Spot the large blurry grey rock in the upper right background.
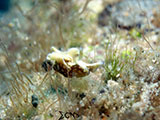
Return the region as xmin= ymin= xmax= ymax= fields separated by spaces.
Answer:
xmin=98 ymin=0 xmax=160 ymax=29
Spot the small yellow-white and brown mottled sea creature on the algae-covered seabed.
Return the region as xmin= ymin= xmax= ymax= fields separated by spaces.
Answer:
xmin=46 ymin=47 xmax=103 ymax=76
